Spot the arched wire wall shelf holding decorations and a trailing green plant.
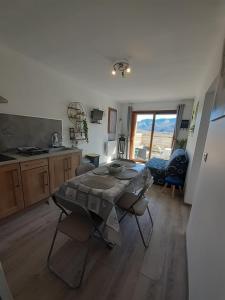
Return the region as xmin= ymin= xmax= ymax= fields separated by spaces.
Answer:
xmin=67 ymin=102 xmax=88 ymax=145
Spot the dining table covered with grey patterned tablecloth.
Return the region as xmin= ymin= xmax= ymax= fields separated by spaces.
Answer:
xmin=55 ymin=160 xmax=153 ymax=245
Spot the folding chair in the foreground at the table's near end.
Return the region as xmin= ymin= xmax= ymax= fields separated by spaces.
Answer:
xmin=47 ymin=193 xmax=104 ymax=288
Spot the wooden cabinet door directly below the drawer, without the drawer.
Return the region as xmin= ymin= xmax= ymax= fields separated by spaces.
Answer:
xmin=22 ymin=166 xmax=49 ymax=207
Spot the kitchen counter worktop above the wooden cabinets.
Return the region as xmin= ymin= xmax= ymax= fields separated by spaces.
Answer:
xmin=0 ymin=148 xmax=82 ymax=166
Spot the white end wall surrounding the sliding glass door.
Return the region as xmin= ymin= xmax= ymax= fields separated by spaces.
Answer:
xmin=119 ymin=99 xmax=194 ymax=139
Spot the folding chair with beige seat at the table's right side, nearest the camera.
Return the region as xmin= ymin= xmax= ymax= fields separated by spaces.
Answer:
xmin=117 ymin=180 xmax=154 ymax=248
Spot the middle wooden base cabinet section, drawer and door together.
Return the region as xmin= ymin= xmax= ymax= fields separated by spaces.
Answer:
xmin=21 ymin=159 xmax=49 ymax=207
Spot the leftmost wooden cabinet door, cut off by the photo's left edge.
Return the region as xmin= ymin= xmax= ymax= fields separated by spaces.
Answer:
xmin=0 ymin=164 xmax=24 ymax=218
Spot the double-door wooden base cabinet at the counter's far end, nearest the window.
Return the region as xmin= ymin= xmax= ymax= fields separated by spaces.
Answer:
xmin=49 ymin=153 xmax=80 ymax=193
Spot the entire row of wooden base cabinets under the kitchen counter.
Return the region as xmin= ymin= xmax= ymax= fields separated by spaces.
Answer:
xmin=0 ymin=152 xmax=81 ymax=218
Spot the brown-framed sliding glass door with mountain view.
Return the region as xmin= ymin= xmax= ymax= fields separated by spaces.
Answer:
xmin=130 ymin=111 xmax=176 ymax=161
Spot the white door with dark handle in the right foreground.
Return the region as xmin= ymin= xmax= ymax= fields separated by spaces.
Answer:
xmin=187 ymin=118 xmax=225 ymax=300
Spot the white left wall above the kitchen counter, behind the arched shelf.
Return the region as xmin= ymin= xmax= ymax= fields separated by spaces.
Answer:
xmin=0 ymin=46 xmax=116 ymax=161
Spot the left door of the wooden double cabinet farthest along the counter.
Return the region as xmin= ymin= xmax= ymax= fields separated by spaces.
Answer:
xmin=49 ymin=155 xmax=70 ymax=193
